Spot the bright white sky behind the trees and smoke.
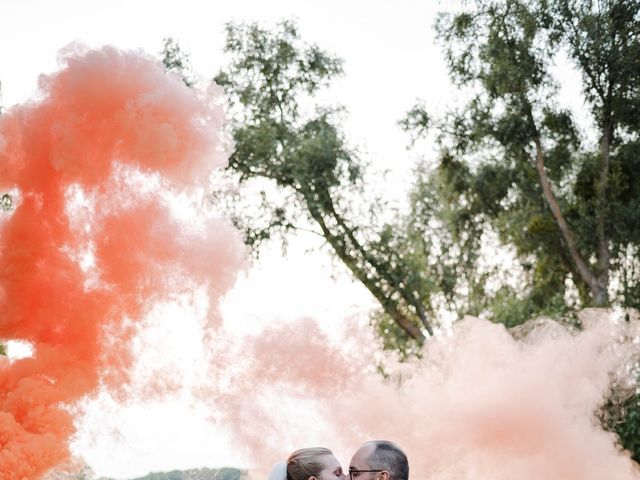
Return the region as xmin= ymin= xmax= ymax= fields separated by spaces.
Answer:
xmin=0 ymin=0 xmax=584 ymax=477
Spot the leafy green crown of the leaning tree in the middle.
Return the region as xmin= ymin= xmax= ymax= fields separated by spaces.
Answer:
xmin=215 ymin=21 xmax=350 ymax=244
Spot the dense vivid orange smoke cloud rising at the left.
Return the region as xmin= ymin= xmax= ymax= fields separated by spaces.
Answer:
xmin=0 ymin=46 xmax=243 ymax=480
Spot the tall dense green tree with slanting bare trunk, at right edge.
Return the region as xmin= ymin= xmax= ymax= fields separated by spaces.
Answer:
xmin=403 ymin=0 xmax=640 ymax=323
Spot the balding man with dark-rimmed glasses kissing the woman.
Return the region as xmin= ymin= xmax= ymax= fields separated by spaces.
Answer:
xmin=349 ymin=440 xmax=409 ymax=480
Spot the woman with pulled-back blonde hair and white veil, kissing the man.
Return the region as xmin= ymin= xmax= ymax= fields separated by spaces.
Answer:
xmin=268 ymin=447 xmax=348 ymax=480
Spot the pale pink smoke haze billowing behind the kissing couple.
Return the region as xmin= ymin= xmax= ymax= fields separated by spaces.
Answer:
xmin=224 ymin=312 xmax=640 ymax=480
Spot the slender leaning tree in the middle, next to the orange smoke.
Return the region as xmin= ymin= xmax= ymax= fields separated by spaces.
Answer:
xmin=215 ymin=21 xmax=440 ymax=345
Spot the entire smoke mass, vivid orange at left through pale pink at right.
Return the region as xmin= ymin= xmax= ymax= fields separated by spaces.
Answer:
xmin=0 ymin=45 xmax=640 ymax=480
